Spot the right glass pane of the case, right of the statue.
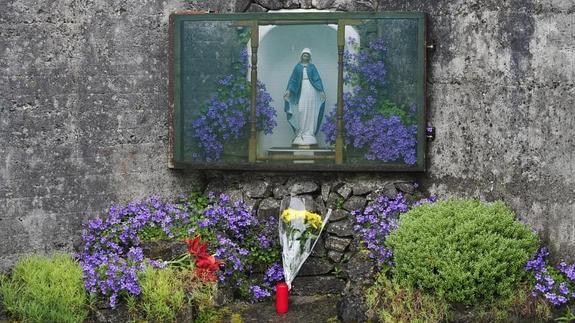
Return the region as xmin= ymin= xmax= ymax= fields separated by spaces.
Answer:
xmin=336 ymin=18 xmax=423 ymax=166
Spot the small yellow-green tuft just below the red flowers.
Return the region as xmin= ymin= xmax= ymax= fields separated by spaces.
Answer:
xmin=139 ymin=267 xmax=186 ymax=322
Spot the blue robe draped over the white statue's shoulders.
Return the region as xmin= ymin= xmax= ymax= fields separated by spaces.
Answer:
xmin=284 ymin=63 xmax=325 ymax=135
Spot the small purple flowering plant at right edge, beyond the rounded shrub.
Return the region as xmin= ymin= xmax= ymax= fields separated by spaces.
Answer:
xmin=525 ymin=247 xmax=575 ymax=306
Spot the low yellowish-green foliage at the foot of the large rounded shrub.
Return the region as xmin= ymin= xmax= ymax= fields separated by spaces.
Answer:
xmin=366 ymin=271 xmax=449 ymax=323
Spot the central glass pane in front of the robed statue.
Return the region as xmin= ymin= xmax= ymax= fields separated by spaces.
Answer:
xmin=258 ymin=24 xmax=337 ymax=163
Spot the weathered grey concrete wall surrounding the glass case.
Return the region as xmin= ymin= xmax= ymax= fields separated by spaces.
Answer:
xmin=0 ymin=0 xmax=575 ymax=268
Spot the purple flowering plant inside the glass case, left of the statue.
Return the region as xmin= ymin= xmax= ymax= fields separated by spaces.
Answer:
xmin=190 ymin=49 xmax=276 ymax=161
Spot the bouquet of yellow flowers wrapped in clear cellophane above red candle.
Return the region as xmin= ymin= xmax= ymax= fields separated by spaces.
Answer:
xmin=279 ymin=196 xmax=331 ymax=289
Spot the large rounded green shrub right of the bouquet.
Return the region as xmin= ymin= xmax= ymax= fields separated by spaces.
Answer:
xmin=386 ymin=200 xmax=538 ymax=305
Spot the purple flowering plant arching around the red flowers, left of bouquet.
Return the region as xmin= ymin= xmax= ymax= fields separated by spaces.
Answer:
xmin=77 ymin=194 xmax=283 ymax=307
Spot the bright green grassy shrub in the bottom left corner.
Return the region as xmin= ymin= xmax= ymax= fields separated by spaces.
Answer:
xmin=0 ymin=254 xmax=88 ymax=322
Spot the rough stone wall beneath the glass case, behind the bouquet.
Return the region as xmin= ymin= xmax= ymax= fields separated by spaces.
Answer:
xmin=200 ymin=174 xmax=423 ymax=322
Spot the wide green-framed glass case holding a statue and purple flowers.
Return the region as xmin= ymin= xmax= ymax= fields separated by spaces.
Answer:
xmin=169 ymin=12 xmax=426 ymax=171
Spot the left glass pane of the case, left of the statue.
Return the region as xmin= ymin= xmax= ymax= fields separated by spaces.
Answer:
xmin=180 ymin=21 xmax=251 ymax=163
